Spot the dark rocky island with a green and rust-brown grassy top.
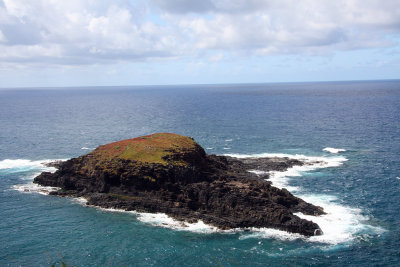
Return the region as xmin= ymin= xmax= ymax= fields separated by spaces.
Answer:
xmin=34 ymin=133 xmax=324 ymax=236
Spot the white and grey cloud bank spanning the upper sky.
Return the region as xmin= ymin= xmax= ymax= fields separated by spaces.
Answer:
xmin=0 ymin=0 xmax=400 ymax=68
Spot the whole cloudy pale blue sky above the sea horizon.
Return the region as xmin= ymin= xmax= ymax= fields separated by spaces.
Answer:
xmin=0 ymin=0 xmax=400 ymax=88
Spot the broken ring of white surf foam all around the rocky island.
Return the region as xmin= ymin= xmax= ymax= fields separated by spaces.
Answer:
xmin=9 ymin=153 xmax=385 ymax=245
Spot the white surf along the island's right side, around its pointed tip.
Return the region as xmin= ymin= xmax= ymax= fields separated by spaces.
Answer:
xmin=228 ymin=153 xmax=385 ymax=245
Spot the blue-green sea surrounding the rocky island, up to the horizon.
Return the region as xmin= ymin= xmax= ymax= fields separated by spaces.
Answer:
xmin=0 ymin=80 xmax=400 ymax=266
